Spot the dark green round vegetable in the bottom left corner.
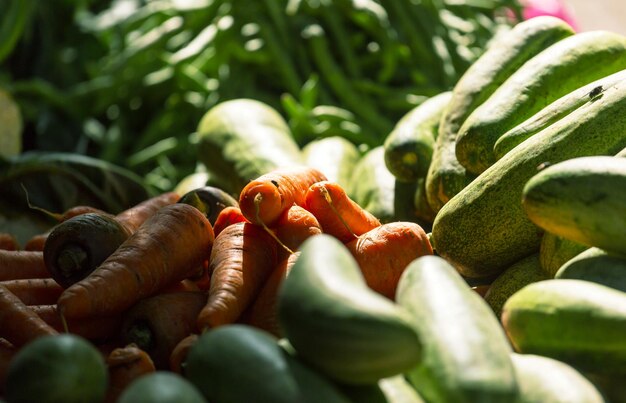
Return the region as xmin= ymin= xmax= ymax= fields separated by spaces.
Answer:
xmin=4 ymin=334 xmax=108 ymax=403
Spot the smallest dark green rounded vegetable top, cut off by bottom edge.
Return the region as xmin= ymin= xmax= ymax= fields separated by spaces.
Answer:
xmin=117 ymin=371 xmax=206 ymax=403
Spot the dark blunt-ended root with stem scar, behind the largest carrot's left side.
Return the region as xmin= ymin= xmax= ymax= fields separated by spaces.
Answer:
xmin=43 ymin=213 xmax=130 ymax=288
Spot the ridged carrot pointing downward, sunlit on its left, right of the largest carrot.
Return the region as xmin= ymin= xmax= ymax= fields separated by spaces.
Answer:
xmin=197 ymin=222 xmax=278 ymax=331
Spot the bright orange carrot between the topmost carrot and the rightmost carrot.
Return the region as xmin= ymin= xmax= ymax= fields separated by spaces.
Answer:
xmin=305 ymin=181 xmax=381 ymax=243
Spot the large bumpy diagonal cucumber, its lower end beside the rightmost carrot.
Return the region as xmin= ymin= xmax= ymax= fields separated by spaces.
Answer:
xmin=431 ymin=81 xmax=626 ymax=278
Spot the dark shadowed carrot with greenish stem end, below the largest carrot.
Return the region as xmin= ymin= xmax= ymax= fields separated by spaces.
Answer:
xmin=120 ymin=292 xmax=207 ymax=369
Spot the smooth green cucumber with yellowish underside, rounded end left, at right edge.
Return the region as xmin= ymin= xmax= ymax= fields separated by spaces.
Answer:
xmin=522 ymin=156 xmax=626 ymax=256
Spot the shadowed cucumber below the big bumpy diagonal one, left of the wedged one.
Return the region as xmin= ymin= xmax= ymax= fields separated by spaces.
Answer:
xmin=484 ymin=253 xmax=548 ymax=318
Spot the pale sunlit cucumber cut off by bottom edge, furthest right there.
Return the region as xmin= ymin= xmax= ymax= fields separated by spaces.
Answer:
xmin=511 ymin=353 xmax=604 ymax=403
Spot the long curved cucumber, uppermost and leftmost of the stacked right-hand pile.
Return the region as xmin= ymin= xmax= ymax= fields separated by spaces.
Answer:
xmin=426 ymin=16 xmax=574 ymax=212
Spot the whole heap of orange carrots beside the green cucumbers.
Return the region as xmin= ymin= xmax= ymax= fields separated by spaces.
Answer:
xmin=0 ymin=167 xmax=433 ymax=395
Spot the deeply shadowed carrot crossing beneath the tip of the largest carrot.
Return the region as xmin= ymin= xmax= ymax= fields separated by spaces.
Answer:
xmin=29 ymin=304 xmax=122 ymax=342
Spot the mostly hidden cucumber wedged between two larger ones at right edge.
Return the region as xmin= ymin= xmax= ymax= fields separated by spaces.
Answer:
xmin=554 ymin=248 xmax=626 ymax=292
